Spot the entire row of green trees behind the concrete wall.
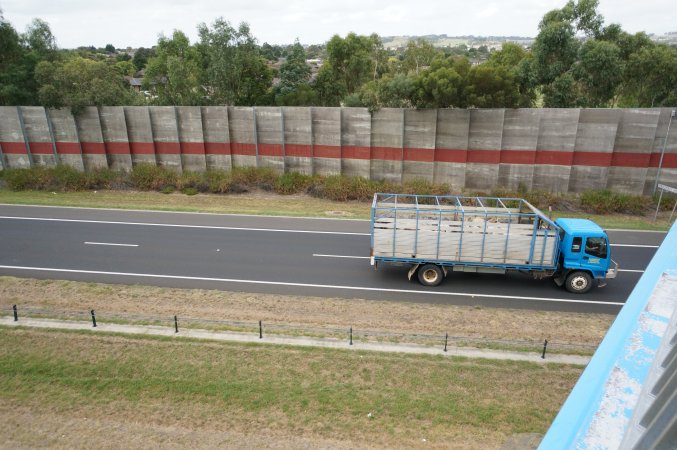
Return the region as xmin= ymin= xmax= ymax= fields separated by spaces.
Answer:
xmin=0 ymin=0 xmax=677 ymax=113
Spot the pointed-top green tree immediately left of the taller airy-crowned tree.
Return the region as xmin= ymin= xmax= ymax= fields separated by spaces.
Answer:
xmin=143 ymin=30 xmax=204 ymax=106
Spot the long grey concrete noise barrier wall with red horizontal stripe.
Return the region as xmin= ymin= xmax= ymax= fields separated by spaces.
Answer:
xmin=0 ymin=106 xmax=677 ymax=194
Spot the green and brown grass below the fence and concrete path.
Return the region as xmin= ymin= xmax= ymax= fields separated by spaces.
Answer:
xmin=0 ymin=328 xmax=581 ymax=448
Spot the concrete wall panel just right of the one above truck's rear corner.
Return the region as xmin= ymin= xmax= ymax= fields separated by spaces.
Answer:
xmin=402 ymin=109 xmax=437 ymax=182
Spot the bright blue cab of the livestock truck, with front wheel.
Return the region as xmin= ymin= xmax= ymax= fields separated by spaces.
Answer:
xmin=555 ymin=219 xmax=618 ymax=294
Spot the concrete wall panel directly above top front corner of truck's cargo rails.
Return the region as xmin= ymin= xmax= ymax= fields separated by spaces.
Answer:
xmin=498 ymin=109 xmax=541 ymax=189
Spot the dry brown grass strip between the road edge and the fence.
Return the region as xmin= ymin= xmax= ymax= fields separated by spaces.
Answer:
xmin=0 ymin=277 xmax=614 ymax=346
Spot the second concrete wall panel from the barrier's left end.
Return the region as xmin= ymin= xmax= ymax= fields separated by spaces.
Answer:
xmin=19 ymin=106 xmax=58 ymax=167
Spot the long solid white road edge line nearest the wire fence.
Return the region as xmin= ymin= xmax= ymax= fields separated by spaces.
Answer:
xmin=0 ymin=265 xmax=625 ymax=306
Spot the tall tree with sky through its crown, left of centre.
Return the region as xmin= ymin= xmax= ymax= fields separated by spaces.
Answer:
xmin=198 ymin=17 xmax=273 ymax=105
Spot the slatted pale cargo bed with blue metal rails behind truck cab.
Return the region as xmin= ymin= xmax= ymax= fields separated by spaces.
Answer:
xmin=371 ymin=193 xmax=559 ymax=269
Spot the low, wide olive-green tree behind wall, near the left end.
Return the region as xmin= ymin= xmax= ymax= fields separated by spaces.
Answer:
xmin=35 ymin=56 xmax=139 ymax=114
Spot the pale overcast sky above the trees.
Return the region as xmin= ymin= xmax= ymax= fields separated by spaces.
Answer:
xmin=0 ymin=0 xmax=677 ymax=48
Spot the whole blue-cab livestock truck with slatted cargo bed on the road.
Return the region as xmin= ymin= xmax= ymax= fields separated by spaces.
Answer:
xmin=370 ymin=193 xmax=618 ymax=294
